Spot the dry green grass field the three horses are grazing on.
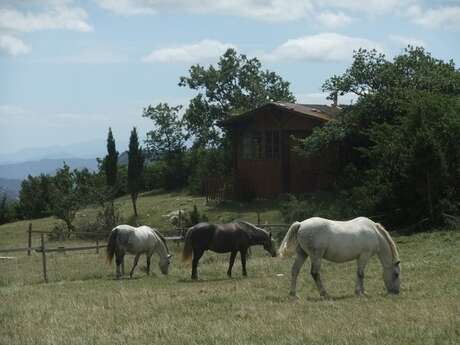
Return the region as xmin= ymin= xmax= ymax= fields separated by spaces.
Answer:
xmin=0 ymin=193 xmax=460 ymax=344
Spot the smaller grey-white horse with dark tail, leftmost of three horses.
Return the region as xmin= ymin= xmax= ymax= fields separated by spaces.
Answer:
xmin=107 ymin=225 xmax=171 ymax=279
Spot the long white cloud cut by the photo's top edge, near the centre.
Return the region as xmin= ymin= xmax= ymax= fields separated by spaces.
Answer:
xmin=96 ymin=0 xmax=313 ymax=22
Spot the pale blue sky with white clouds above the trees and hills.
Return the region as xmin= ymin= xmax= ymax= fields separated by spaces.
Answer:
xmin=0 ymin=0 xmax=460 ymax=154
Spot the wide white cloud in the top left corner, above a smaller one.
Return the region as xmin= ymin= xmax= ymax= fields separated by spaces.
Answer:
xmin=0 ymin=5 xmax=92 ymax=32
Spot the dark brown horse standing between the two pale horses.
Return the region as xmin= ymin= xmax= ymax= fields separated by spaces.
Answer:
xmin=182 ymin=221 xmax=276 ymax=280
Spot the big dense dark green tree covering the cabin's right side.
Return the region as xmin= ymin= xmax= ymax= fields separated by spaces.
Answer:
xmin=301 ymin=47 xmax=460 ymax=223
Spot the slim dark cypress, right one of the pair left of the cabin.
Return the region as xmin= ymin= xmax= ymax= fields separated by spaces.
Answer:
xmin=128 ymin=127 xmax=144 ymax=217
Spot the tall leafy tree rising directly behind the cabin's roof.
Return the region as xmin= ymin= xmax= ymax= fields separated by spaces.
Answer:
xmin=179 ymin=49 xmax=295 ymax=147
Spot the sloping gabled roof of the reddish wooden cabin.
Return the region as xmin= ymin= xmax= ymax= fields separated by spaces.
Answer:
xmin=221 ymin=102 xmax=341 ymax=126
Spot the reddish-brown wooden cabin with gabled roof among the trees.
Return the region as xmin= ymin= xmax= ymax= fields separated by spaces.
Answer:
xmin=221 ymin=102 xmax=340 ymax=197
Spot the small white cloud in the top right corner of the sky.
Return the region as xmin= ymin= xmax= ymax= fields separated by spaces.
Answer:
xmin=408 ymin=5 xmax=460 ymax=29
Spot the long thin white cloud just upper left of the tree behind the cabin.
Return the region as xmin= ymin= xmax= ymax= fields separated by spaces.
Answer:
xmin=142 ymin=40 xmax=236 ymax=63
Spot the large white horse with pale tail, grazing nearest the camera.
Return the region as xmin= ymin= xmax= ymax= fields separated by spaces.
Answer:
xmin=279 ymin=217 xmax=401 ymax=296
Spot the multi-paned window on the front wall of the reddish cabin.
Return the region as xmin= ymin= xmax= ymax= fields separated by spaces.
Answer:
xmin=241 ymin=131 xmax=280 ymax=159
